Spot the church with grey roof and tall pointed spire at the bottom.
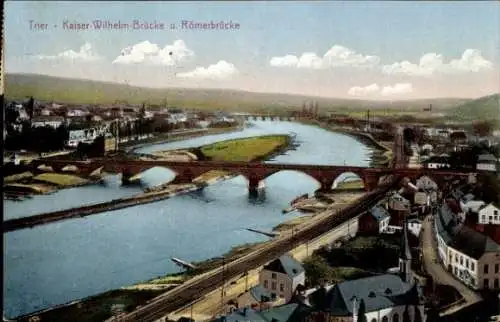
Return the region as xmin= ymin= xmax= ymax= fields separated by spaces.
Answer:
xmin=308 ymin=221 xmax=425 ymax=322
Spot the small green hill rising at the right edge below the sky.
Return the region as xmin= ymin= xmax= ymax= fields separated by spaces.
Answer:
xmin=449 ymin=93 xmax=500 ymax=121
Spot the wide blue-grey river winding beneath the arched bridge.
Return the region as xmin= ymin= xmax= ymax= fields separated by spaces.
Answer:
xmin=4 ymin=121 xmax=371 ymax=317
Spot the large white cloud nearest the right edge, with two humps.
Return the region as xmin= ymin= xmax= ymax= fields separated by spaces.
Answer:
xmin=382 ymin=49 xmax=493 ymax=76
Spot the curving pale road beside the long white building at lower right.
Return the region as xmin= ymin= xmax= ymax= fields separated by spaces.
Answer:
xmin=422 ymin=216 xmax=482 ymax=312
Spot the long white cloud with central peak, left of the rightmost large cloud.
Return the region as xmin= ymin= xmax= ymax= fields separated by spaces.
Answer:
xmin=269 ymin=45 xmax=380 ymax=69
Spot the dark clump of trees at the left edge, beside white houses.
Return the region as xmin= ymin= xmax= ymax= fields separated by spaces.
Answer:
xmin=4 ymin=122 xmax=69 ymax=153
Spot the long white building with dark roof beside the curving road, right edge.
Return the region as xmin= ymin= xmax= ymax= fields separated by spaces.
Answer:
xmin=434 ymin=204 xmax=500 ymax=289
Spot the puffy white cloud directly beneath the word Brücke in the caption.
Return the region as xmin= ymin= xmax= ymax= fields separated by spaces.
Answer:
xmin=113 ymin=40 xmax=194 ymax=66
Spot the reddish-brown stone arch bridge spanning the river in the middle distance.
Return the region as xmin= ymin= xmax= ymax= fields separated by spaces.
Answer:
xmin=31 ymin=158 xmax=469 ymax=192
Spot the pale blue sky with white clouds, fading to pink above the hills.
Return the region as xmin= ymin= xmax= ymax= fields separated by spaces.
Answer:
xmin=5 ymin=1 xmax=500 ymax=100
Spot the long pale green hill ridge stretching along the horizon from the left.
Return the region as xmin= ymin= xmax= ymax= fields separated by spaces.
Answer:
xmin=5 ymin=74 xmax=467 ymax=112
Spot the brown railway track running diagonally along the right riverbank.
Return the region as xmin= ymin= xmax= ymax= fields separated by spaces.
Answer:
xmin=107 ymin=176 xmax=401 ymax=322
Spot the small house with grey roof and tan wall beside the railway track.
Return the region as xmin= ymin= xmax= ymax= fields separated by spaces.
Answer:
xmin=259 ymin=255 xmax=306 ymax=302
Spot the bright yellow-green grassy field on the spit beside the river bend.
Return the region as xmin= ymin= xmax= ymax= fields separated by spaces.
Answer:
xmin=201 ymin=135 xmax=289 ymax=162
